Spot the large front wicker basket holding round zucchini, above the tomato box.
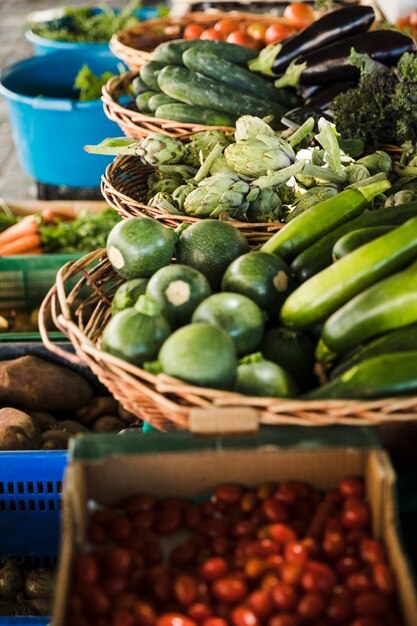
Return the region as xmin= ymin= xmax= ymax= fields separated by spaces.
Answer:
xmin=39 ymin=250 xmax=417 ymax=430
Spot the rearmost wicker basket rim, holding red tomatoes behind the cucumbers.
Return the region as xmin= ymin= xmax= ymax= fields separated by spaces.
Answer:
xmin=110 ymin=11 xmax=283 ymax=70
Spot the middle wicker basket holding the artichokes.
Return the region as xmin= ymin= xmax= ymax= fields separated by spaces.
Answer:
xmin=101 ymin=156 xmax=284 ymax=246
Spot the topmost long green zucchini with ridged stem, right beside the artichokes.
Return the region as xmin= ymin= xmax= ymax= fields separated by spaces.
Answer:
xmin=261 ymin=180 xmax=391 ymax=259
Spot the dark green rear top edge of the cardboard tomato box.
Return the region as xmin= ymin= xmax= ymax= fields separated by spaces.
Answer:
xmin=70 ymin=426 xmax=381 ymax=461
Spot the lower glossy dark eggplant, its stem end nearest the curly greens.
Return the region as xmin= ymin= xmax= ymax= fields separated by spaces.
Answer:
xmin=275 ymin=30 xmax=416 ymax=87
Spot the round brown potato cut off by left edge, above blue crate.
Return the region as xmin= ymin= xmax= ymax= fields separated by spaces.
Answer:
xmin=0 ymin=408 xmax=41 ymax=451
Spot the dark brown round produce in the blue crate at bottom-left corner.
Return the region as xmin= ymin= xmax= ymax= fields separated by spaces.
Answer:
xmin=0 ymin=557 xmax=55 ymax=616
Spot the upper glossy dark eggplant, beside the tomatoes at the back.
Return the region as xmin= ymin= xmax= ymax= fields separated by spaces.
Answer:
xmin=272 ymin=6 xmax=375 ymax=74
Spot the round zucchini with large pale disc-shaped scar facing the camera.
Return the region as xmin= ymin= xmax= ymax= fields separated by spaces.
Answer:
xmin=146 ymin=264 xmax=211 ymax=328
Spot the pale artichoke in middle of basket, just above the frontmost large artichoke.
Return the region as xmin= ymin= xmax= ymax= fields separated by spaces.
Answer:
xmin=224 ymin=135 xmax=295 ymax=178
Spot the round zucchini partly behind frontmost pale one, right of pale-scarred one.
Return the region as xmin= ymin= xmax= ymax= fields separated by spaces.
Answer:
xmin=192 ymin=293 xmax=265 ymax=355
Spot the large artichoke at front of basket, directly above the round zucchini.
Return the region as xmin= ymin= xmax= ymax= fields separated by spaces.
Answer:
xmin=184 ymin=174 xmax=259 ymax=217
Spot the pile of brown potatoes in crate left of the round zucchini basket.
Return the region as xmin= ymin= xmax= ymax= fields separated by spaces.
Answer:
xmin=0 ymin=356 xmax=140 ymax=448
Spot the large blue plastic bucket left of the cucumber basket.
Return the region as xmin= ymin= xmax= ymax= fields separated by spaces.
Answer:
xmin=0 ymin=50 xmax=125 ymax=187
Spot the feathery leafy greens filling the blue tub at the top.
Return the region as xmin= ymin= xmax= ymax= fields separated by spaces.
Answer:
xmin=32 ymin=0 xmax=141 ymax=43
